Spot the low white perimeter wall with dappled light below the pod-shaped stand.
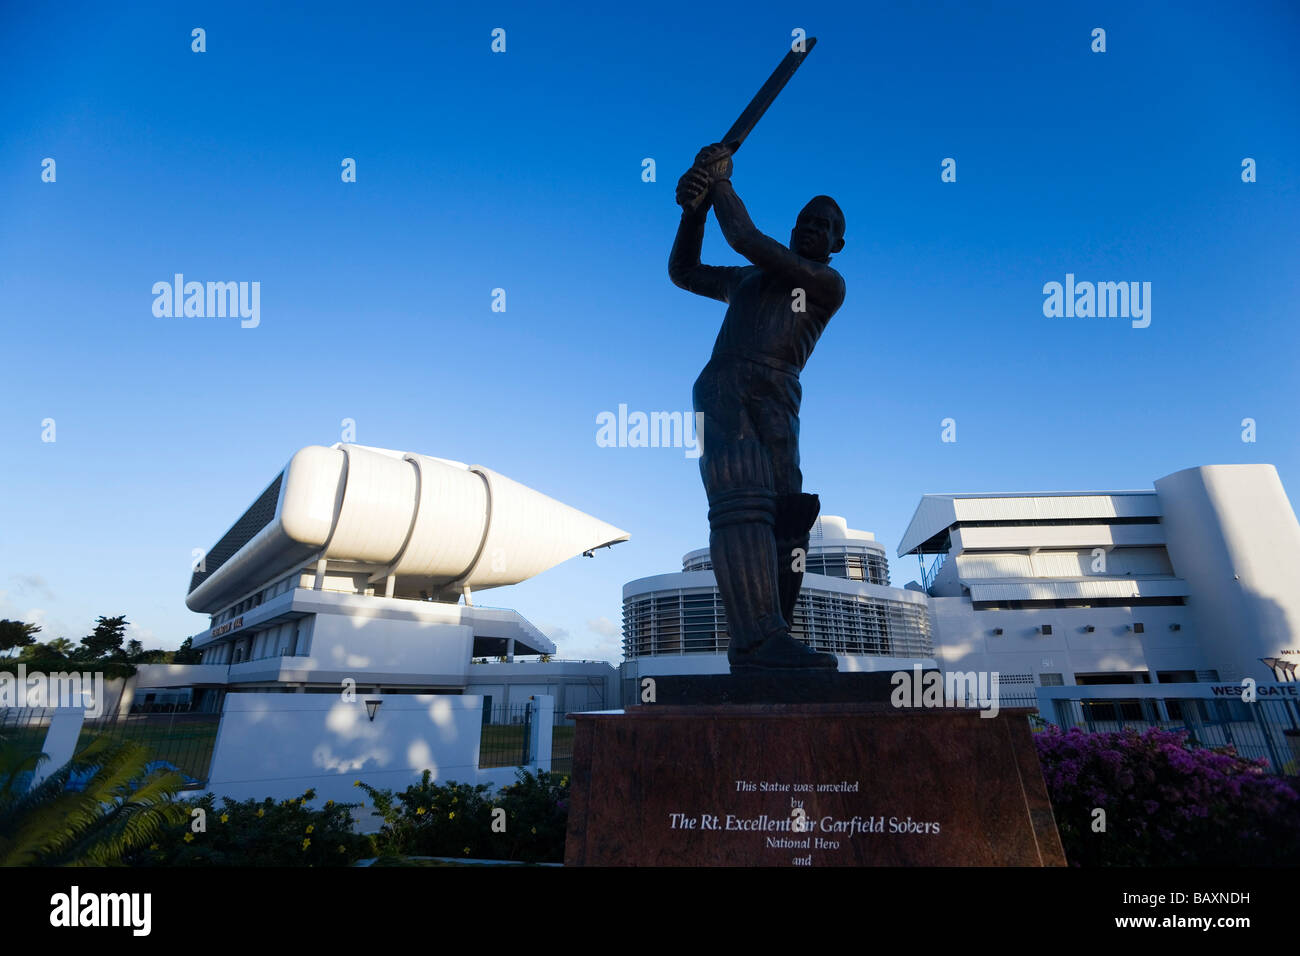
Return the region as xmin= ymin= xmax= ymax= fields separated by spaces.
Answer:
xmin=207 ymin=693 xmax=554 ymax=803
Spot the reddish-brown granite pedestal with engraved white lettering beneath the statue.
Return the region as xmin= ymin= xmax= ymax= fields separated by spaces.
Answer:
xmin=564 ymin=702 xmax=1065 ymax=866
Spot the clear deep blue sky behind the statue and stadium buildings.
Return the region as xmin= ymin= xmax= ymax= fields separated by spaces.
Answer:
xmin=0 ymin=0 xmax=1300 ymax=661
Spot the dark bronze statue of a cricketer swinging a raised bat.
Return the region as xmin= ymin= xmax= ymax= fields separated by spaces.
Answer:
xmin=668 ymin=39 xmax=844 ymax=674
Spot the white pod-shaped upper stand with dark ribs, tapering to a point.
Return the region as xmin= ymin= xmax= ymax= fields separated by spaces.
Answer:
xmin=186 ymin=444 xmax=628 ymax=613
